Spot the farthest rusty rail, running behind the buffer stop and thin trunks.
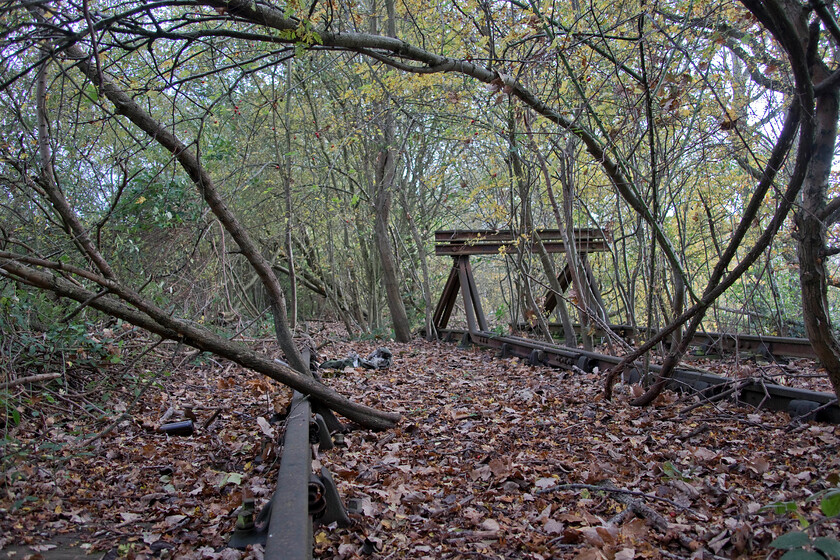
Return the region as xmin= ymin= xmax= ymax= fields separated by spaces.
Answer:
xmin=518 ymin=323 xmax=817 ymax=359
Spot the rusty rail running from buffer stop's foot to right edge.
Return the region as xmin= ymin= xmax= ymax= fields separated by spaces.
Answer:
xmin=438 ymin=329 xmax=840 ymax=424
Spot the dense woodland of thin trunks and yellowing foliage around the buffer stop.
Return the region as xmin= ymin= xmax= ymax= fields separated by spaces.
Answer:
xmin=0 ymin=0 xmax=840 ymax=412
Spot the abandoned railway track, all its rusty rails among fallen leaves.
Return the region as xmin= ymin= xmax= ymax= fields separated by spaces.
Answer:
xmin=230 ymin=326 xmax=840 ymax=560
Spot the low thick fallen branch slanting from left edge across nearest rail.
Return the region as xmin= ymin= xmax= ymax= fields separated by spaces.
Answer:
xmin=0 ymin=251 xmax=400 ymax=430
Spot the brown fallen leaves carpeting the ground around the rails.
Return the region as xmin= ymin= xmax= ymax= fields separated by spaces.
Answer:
xmin=0 ymin=330 xmax=840 ymax=560
